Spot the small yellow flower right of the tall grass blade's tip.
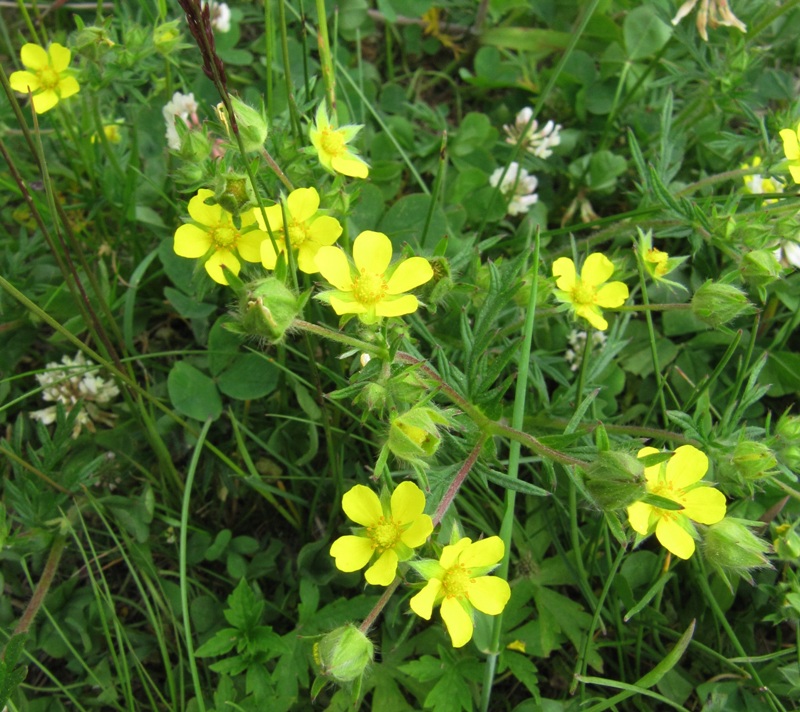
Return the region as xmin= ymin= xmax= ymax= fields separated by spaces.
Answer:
xmin=553 ymin=252 xmax=628 ymax=331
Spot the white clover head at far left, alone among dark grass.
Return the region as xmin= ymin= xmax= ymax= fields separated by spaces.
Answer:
xmin=31 ymin=353 xmax=119 ymax=438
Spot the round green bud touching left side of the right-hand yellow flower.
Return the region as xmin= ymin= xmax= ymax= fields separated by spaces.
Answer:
xmin=584 ymin=450 xmax=647 ymax=511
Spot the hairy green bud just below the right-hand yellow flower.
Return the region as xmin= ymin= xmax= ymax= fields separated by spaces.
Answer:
xmin=703 ymin=517 xmax=770 ymax=583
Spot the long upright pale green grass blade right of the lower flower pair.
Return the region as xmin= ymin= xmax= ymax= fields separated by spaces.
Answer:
xmin=481 ymin=230 xmax=539 ymax=712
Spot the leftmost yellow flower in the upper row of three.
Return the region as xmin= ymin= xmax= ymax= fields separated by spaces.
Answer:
xmin=175 ymin=188 xmax=268 ymax=284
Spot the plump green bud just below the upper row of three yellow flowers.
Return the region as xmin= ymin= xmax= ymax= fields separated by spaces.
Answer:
xmin=236 ymin=277 xmax=305 ymax=344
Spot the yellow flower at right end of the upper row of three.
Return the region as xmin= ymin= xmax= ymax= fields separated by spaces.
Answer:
xmin=316 ymin=230 xmax=433 ymax=324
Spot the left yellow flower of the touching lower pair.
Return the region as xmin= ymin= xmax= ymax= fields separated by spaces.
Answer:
xmin=331 ymin=482 xmax=433 ymax=586
